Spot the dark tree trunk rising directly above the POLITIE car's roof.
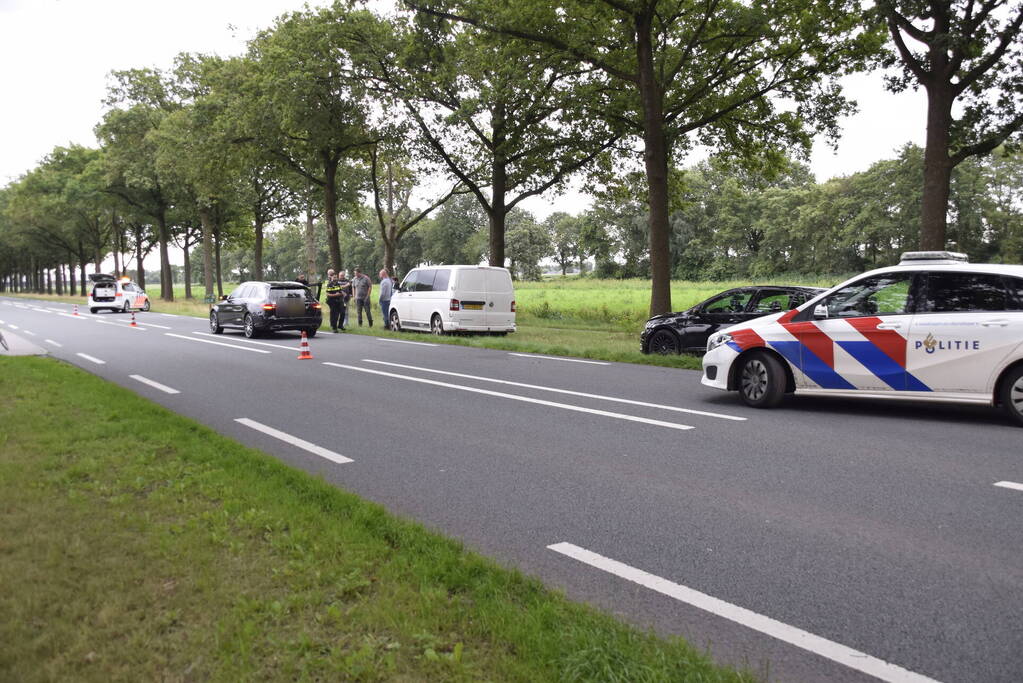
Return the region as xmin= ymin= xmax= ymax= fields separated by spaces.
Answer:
xmin=920 ymin=79 xmax=953 ymax=252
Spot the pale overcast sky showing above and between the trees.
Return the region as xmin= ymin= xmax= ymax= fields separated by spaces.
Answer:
xmin=0 ymin=0 xmax=925 ymax=218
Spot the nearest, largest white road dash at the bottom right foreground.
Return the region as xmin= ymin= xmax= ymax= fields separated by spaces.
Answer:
xmin=547 ymin=543 xmax=937 ymax=683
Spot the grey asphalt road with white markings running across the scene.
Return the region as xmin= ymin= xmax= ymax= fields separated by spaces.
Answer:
xmin=0 ymin=299 xmax=1023 ymax=682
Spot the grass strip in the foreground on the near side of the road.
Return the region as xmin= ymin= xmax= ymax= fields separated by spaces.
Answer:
xmin=0 ymin=358 xmax=753 ymax=683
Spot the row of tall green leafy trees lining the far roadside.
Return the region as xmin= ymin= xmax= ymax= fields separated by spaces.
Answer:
xmin=0 ymin=0 xmax=1023 ymax=313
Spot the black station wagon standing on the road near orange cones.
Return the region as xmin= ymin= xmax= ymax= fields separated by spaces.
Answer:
xmin=210 ymin=282 xmax=323 ymax=338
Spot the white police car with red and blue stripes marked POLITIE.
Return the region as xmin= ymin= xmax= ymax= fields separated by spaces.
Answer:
xmin=702 ymin=252 xmax=1023 ymax=424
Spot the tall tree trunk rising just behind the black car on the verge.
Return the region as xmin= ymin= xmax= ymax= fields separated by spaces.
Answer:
xmin=636 ymin=14 xmax=671 ymax=316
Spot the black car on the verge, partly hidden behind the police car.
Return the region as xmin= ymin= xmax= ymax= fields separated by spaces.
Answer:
xmin=639 ymin=285 xmax=824 ymax=355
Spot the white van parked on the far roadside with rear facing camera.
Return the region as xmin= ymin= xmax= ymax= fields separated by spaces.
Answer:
xmin=388 ymin=266 xmax=515 ymax=334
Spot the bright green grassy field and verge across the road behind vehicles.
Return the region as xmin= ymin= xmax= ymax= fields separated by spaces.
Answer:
xmin=6 ymin=277 xmax=840 ymax=369
